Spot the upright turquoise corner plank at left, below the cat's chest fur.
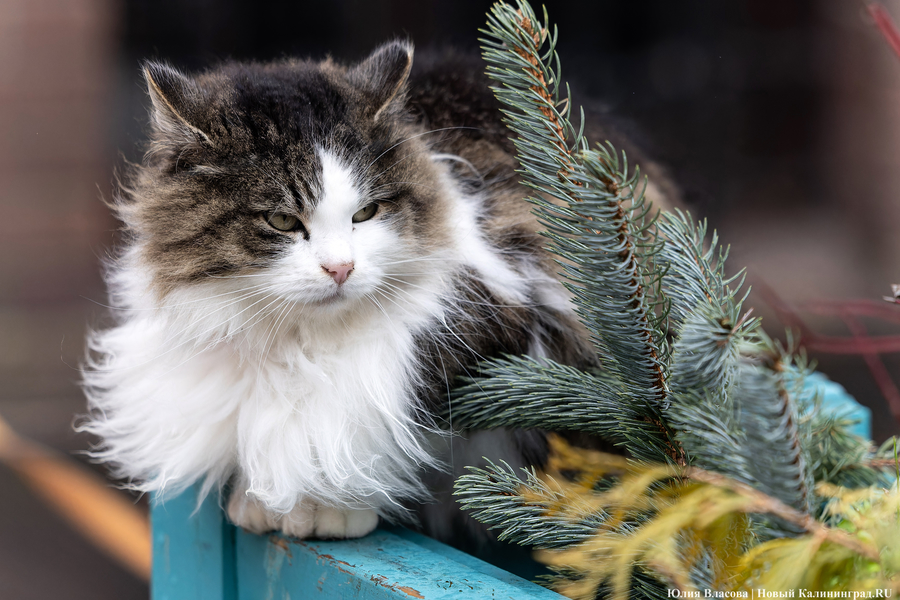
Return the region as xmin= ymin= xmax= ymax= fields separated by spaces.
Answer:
xmin=150 ymin=487 xmax=237 ymax=600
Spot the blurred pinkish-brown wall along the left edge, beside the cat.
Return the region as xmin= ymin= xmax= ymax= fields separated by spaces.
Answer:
xmin=0 ymin=0 xmax=119 ymax=446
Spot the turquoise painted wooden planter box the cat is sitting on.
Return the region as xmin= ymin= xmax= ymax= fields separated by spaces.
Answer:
xmin=151 ymin=375 xmax=872 ymax=600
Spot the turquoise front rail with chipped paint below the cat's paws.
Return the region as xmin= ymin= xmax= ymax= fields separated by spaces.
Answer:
xmin=236 ymin=530 xmax=561 ymax=600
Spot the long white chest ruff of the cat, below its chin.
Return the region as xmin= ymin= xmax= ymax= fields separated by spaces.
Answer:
xmin=89 ymin=270 xmax=437 ymax=513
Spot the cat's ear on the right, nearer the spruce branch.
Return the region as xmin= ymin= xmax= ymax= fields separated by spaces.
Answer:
xmin=347 ymin=40 xmax=413 ymax=121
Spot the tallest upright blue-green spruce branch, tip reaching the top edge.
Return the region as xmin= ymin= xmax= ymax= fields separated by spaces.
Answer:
xmin=481 ymin=1 xmax=686 ymax=463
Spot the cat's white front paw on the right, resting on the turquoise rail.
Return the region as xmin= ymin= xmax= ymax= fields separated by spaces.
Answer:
xmin=281 ymin=501 xmax=378 ymax=539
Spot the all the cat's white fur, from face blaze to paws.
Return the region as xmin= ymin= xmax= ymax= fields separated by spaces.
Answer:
xmin=82 ymin=151 xmax=548 ymax=537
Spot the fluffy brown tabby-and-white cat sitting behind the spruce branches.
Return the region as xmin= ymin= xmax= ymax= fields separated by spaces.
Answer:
xmin=82 ymin=42 xmax=593 ymax=537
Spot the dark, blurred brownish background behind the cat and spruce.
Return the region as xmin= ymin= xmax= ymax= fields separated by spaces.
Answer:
xmin=0 ymin=0 xmax=900 ymax=600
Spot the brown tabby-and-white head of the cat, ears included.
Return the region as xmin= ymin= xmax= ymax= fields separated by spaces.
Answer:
xmin=120 ymin=42 xmax=447 ymax=314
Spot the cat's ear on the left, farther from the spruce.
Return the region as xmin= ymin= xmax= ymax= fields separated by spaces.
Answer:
xmin=143 ymin=61 xmax=212 ymax=144
